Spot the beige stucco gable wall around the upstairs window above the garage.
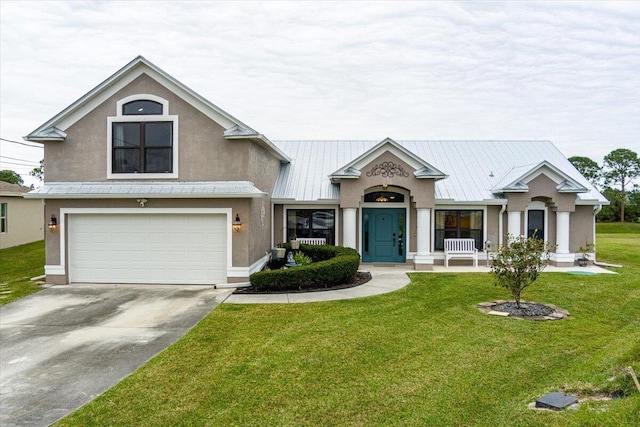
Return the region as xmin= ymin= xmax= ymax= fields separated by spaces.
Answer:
xmin=44 ymin=74 xmax=258 ymax=184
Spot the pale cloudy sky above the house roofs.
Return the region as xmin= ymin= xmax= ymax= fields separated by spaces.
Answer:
xmin=0 ymin=0 xmax=640 ymax=183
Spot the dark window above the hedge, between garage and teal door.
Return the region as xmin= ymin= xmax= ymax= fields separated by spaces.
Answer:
xmin=287 ymin=209 xmax=336 ymax=245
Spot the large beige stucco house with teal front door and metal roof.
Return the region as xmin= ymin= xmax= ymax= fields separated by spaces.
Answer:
xmin=25 ymin=57 xmax=608 ymax=284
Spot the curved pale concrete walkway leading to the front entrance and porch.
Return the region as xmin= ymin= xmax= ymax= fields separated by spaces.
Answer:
xmin=224 ymin=264 xmax=616 ymax=304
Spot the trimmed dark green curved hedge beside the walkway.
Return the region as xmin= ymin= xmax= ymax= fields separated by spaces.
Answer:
xmin=249 ymin=244 xmax=360 ymax=291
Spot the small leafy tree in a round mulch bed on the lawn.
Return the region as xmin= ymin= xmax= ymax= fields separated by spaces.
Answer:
xmin=491 ymin=233 xmax=551 ymax=308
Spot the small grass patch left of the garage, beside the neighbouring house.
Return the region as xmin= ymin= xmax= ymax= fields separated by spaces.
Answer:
xmin=0 ymin=240 xmax=44 ymax=305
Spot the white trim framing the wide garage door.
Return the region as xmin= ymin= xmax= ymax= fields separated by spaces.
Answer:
xmin=45 ymin=208 xmax=235 ymax=275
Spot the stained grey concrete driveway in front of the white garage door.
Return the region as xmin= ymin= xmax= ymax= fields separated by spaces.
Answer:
xmin=0 ymin=284 xmax=232 ymax=426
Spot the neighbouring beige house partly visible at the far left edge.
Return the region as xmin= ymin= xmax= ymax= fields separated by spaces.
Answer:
xmin=0 ymin=181 xmax=44 ymax=249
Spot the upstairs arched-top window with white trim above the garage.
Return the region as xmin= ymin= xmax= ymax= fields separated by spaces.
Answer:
xmin=107 ymin=95 xmax=178 ymax=179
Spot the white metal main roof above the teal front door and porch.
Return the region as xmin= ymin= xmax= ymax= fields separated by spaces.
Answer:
xmin=273 ymin=140 xmax=608 ymax=204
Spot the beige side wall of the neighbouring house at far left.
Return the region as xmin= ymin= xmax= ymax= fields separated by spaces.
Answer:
xmin=0 ymin=195 xmax=46 ymax=249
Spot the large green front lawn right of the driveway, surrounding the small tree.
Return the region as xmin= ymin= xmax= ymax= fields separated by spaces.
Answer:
xmin=58 ymin=225 xmax=640 ymax=426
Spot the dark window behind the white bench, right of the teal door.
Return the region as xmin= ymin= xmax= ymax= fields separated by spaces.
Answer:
xmin=434 ymin=210 xmax=483 ymax=251
